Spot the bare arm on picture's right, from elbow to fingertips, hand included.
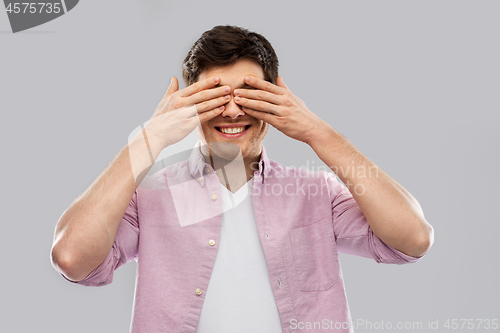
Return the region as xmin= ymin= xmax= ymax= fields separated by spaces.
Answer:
xmin=229 ymin=76 xmax=433 ymax=257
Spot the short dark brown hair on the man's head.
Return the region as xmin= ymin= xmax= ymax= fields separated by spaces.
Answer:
xmin=182 ymin=25 xmax=278 ymax=86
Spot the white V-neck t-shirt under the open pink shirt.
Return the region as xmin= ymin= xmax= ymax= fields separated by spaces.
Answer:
xmin=196 ymin=179 xmax=282 ymax=333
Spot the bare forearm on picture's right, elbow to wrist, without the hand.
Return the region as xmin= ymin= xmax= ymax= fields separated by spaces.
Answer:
xmin=308 ymin=126 xmax=433 ymax=257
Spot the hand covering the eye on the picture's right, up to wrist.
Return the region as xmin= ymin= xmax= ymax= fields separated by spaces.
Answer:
xmin=234 ymin=76 xmax=331 ymax=143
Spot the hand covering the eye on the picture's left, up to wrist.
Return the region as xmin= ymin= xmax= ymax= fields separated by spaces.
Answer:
xmin=145 ymin=77 xmax=231 ymax=150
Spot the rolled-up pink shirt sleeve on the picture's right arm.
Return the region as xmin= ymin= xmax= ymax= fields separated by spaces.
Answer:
xmin=327 ymin=174 xmax=423 ymax=264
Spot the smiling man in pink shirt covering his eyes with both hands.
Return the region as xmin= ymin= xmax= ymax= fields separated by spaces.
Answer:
xmin=52 ymin=26 xmax=433 ymax=333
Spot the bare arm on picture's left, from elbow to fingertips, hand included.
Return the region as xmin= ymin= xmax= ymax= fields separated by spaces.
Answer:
xmin=52 ymin=77 xmax=229 ymax=280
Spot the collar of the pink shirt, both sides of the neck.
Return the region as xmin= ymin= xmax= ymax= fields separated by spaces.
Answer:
xmin=188 ymin=141 xmax=270 ymax=186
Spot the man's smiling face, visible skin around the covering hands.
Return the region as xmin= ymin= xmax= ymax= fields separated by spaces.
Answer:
xmin=198 ymin=59 xmax=269 ymax=160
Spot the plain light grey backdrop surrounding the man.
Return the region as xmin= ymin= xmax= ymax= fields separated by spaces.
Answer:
xmin=0 ymin=0 xmax=500 ymax=333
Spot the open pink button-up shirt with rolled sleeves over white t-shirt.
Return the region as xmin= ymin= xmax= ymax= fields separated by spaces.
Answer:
xmin=63 ymin=146 xmax=420 ymax=333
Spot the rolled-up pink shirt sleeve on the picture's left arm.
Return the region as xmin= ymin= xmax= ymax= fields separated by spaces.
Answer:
xmin=61 ymin=191 xmax=139 ymax=287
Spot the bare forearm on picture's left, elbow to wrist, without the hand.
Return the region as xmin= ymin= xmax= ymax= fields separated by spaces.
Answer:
xmin=52 ymin=133 xmax=159 ymax=280
